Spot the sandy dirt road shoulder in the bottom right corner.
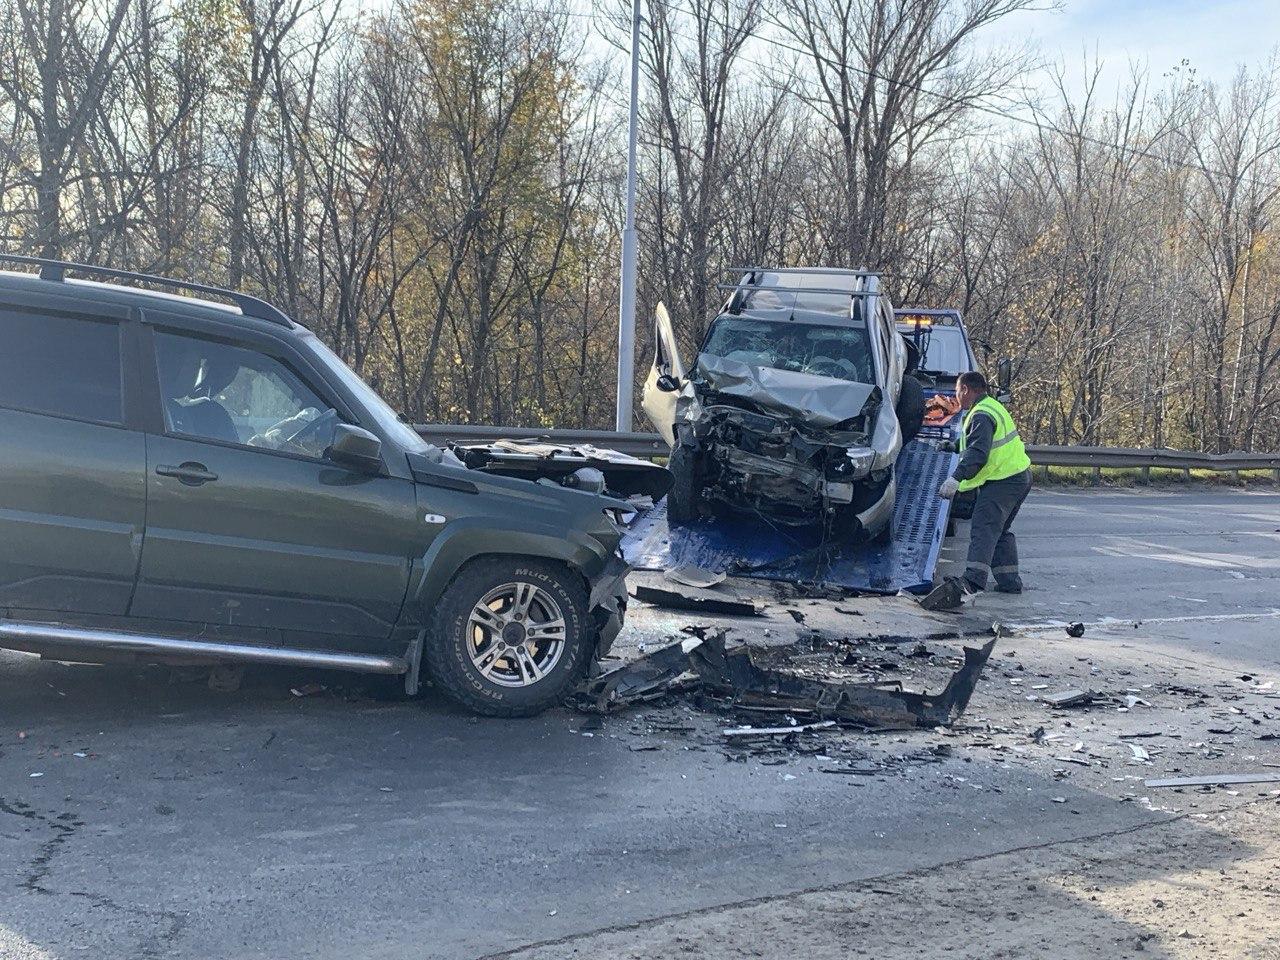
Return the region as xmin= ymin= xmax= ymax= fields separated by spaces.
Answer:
xmin=499 ymin=791 xmax=1280 ymax=960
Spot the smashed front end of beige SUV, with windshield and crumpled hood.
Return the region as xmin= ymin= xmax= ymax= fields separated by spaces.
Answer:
xmin=667 ymin=305 xmax=902 ymax=541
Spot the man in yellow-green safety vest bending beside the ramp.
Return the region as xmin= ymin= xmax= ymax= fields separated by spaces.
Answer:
xmin=920 ymin=371 xmax=1032 ymax=611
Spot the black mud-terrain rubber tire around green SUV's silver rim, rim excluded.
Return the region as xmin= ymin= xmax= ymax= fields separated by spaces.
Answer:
xmin=422 ymin=557 xmax=595 ymax=717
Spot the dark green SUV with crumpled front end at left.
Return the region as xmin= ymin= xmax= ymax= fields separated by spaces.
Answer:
xmin=0 ymin=256 xmax=627 ymax=716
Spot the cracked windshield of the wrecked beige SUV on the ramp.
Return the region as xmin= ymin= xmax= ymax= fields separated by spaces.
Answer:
xmin=703 ymin=315 xmax=876 ymax=383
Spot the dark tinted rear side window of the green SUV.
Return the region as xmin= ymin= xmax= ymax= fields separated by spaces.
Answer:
xmin=0 ymin=307 xmax=123 ymax=424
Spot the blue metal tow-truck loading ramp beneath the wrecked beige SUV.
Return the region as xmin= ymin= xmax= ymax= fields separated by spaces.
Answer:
xmin=622 ymin=428 xmax=957 ymax=594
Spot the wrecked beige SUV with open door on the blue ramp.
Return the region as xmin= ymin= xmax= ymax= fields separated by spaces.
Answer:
xmin=644 ymin=268 xmax=924 ymax=540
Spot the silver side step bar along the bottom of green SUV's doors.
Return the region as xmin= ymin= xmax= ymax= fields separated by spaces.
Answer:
xmin=0 ymin=620 xmax=408 ymax=673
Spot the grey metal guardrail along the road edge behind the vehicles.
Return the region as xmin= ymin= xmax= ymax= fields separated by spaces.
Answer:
xmin=413 ymin=424 xmax=1280 ymax=479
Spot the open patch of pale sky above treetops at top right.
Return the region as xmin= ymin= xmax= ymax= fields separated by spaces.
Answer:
xmin=986 ymin=0 xmax=1280 ymax=92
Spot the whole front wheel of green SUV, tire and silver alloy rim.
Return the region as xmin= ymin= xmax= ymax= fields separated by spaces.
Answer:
xmin=424 ymin=557 xmax=595 ymax=717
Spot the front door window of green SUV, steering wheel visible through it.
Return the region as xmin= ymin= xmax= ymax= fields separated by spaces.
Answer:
xmin=155 ymin=330 xmax=340 ymax=460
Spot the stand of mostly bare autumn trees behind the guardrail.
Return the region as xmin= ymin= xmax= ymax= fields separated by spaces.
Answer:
xmin=0 ymin=0 xmax=1280 ymax=451
